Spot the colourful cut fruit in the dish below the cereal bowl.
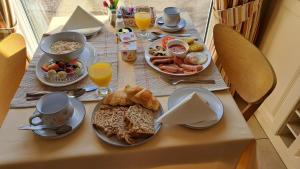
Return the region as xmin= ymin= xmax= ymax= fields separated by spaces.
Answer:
xmin=41 ymin=59 xmax=83 ymax=80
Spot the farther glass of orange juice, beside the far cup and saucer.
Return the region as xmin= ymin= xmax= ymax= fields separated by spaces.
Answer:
xmin=134 ymin=7 xmax=151 ymax=38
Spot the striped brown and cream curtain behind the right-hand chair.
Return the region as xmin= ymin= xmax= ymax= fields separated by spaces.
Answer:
xmin=208 ymin=0 xmax=263 ymax=62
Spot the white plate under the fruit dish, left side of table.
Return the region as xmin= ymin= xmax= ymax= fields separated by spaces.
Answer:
xmin=35 ymin=43 xmax=95 ymax=87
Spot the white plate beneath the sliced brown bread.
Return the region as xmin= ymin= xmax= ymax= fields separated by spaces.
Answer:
xmin=91 ymin=102 xmax=164 ymax=147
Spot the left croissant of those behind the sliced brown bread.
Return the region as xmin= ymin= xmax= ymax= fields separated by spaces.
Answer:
xmin=102 ymin=90 xmax=134 ymax=106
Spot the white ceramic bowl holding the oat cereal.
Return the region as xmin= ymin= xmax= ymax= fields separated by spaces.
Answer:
xmin=40 ymin=32 xmax=86 ymax=61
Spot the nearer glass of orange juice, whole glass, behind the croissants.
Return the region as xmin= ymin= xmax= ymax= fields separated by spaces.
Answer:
xmin=88 ymin=62 xmax=112 ymax=97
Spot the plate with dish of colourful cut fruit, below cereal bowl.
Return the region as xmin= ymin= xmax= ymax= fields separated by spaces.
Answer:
xmin=36 ymin=55 xmax=87 ymax=87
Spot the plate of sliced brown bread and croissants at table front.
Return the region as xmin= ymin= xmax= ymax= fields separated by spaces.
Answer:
xmin=92 ymin=85 xmax=164 ymax=147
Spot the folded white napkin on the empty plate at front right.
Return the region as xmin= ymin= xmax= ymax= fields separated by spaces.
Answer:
xmin=157 ymin=92 xmax=217 ymax=125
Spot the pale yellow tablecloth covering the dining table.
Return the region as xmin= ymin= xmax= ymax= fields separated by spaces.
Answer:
xmin=0 ymin=12 xmax=254 ymax=169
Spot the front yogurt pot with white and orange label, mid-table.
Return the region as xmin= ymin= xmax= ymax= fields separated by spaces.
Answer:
xmin=119 ymin=41 xmax=137 ymax=62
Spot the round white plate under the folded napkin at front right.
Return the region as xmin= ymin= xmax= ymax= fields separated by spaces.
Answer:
xmin=168 ymin=87 xmax=223 ymax=129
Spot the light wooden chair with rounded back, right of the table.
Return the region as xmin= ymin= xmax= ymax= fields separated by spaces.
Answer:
xmin=213 ymin=24 xmax=277 ymax=120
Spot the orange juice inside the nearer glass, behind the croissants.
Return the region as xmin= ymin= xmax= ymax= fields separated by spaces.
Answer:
xmin=88 ymin=63 xmax=112 ymax=87
